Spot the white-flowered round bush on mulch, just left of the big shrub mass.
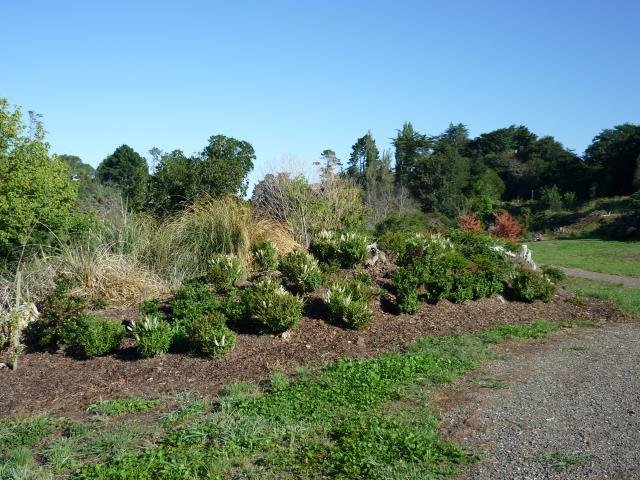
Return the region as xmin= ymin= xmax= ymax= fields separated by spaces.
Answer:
xmin=325 ymin=280 xmax=374 ymax=329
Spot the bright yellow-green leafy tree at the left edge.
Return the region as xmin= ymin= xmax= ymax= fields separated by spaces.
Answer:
xmin=0 ymin=98 xmax=77 ymax=259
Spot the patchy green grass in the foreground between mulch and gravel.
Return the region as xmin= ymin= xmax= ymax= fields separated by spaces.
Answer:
xmin=0 ymin=321 xmax=560 ymax=480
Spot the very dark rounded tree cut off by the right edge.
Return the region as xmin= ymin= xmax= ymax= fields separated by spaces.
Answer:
xmin=584 ymin=123 xmax=640 ymax=196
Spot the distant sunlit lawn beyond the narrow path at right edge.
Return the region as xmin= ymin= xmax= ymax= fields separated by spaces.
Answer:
xmin=529 ymin=240 xmax=640 ymax=277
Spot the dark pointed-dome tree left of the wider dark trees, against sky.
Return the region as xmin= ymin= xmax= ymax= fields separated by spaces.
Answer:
xmin=96 ymin=145 xmax=149 ymax=210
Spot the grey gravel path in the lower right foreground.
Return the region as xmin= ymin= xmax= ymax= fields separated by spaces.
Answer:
xmin=437 ymin=321 xmax=640 ymax=480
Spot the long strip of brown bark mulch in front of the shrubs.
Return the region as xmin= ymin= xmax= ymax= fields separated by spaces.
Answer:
xmin=0 ymin=290 xmax=620 ymax=417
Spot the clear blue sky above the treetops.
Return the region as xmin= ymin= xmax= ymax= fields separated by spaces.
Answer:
xmin=5 ymin=0 xmax=640 ymax=191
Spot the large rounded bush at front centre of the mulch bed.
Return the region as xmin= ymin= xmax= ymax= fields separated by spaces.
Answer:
xmin=243 ymin=278 xmax=303 ymax=333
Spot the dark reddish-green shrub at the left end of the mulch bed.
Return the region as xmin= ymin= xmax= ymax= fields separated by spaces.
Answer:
xmin=34 ymin=277 xmax=87 ymax=348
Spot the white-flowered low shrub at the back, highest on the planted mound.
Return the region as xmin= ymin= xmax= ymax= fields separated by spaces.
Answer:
xmin=309 ymin=230 xmax=368 ymax=268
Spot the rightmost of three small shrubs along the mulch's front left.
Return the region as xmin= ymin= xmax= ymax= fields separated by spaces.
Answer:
xmin=188 ymin=312 xmax=236 ymax=358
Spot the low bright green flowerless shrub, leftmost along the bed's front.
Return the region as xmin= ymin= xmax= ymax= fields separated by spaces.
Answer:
xmin=75 ymin=315 xmax=125 ymax=358
